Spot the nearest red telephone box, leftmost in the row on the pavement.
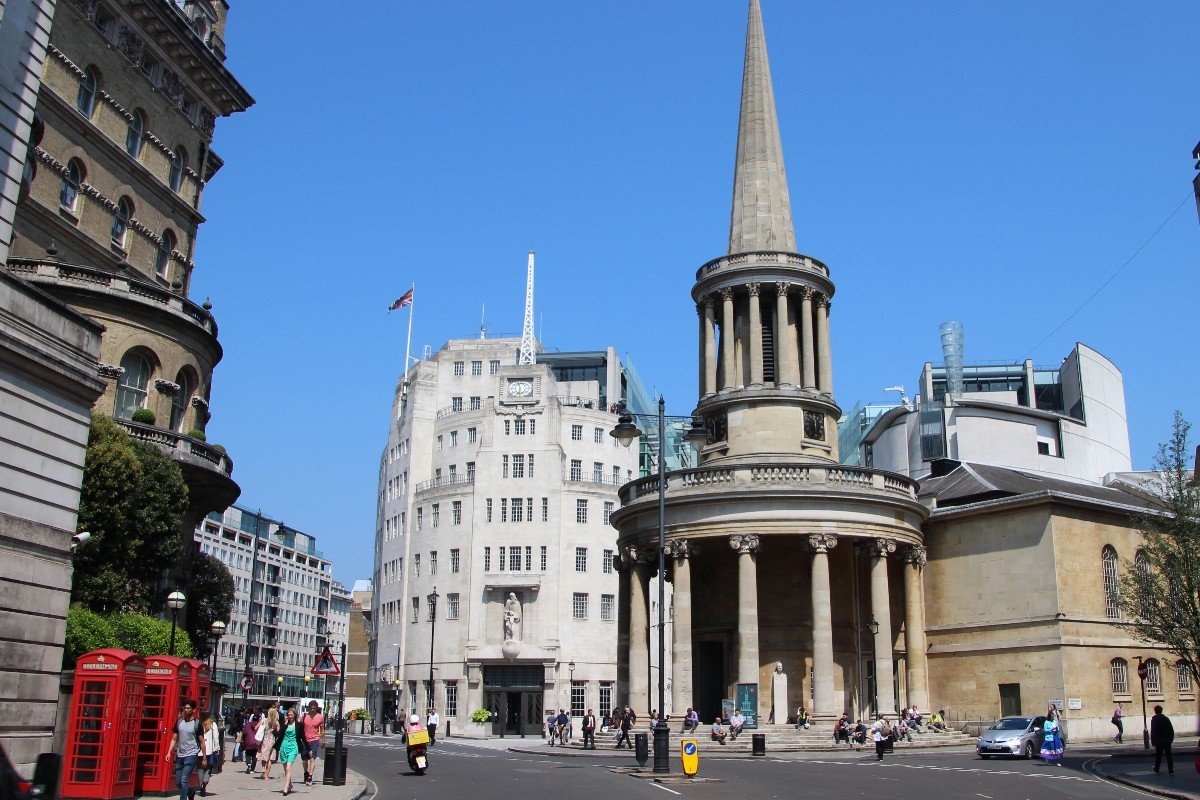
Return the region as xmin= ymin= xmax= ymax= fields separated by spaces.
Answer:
xmin=62 ymin=649 xmax=145 ymax=800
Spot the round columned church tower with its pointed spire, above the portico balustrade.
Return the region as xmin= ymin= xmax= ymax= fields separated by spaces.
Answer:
xmin=691 ymin=0 xmax=840 ymax=463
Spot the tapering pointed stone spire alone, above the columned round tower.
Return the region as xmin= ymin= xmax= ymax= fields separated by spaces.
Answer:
xmin=730 ymin=0 xmax=796 ymax=253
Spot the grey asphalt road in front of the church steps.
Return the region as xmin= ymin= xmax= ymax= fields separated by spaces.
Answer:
xmin=340 ymin=738 xmax=1150 ymax=800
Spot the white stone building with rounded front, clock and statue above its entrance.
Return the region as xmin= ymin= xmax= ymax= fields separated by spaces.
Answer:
xmin=372 ymin=338 xmax=646 ymax=734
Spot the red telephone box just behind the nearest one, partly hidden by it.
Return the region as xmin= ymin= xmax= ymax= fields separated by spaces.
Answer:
xmin=134 ymin=656 xmax=199 ymax=794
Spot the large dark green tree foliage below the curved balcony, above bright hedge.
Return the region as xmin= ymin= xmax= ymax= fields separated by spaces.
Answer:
xmin=71 ymin=414 xmax=187 ymax=613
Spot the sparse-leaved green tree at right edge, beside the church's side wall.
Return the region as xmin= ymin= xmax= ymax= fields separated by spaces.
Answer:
xmin=1114 ymin=411 xmax=1200 ymax=678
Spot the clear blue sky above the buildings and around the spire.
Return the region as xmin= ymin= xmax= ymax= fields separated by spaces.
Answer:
xmin=193 ymin=0 xmax=1200 ymax=583
